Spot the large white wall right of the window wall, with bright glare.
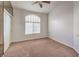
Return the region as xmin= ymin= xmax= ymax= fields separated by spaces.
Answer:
xmin=48 ymin=1 xmax=73 ymax=47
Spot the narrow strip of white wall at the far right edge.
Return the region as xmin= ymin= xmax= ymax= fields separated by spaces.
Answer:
xmin=73 ymin=2 xmax=79 ymax=53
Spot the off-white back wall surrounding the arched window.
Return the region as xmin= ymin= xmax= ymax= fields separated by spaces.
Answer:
xmin=12 ymin=9 xmax=48 ymax=42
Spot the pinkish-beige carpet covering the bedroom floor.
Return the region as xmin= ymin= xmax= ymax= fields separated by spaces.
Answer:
xmin=4 ymin=38 xmax=78 ymax=57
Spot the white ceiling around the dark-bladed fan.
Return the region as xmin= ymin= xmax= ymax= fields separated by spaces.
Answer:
xmin=11 ymin=1 xmax=53 ymax=13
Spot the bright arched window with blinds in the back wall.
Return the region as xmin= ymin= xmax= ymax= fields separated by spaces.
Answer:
xmin=25 ymin=15 xmax=40 ymax=34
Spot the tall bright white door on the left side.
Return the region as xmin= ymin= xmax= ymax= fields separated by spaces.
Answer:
xmin=4 ymin=9 xmax=11 ymax=52
